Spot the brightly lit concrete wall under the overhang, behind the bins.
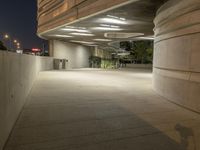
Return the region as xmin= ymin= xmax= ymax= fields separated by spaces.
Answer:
xmin=52 ymin=40 xmax=92 ymax=69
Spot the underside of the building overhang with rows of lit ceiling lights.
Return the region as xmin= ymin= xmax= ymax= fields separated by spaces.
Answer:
xmin=43 ymin=0 xmax=165 ymax=48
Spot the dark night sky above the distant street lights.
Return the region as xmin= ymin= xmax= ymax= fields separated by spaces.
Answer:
xmin=0 ymin=0 xmax=43 ymax=48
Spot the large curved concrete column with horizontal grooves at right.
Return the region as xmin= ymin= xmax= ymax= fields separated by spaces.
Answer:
xmin=153 ymin=0 xmax=200 ymax=112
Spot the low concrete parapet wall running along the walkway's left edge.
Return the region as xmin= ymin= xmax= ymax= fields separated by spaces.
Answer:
xmin=0 ymin=51 xmax=53 ymax=150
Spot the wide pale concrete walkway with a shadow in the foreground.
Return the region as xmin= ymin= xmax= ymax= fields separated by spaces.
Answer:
xmin=5 ymin=70 xmax=200 ymax=150
